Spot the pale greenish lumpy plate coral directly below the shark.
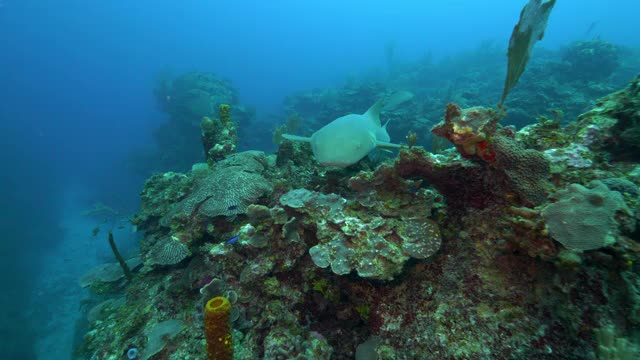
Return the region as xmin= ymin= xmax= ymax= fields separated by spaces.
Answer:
xmin=280 ymin=181 xmax=441 ymax=280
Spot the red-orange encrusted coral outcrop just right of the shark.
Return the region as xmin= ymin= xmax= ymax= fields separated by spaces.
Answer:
xmin=412 ymin=104 xmax=550 ymax=207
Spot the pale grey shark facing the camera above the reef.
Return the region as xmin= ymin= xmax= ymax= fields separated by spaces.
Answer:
xmin=283 ymin=100 xmax=401 ymax=167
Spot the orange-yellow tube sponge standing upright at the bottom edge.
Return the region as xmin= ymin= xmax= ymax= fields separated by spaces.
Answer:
xmin=204 ymin=296 xmax=233 ymax=360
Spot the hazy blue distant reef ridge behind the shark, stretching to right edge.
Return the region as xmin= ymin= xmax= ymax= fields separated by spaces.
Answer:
xmin=278 ymin=40 xmax=639 ymax=148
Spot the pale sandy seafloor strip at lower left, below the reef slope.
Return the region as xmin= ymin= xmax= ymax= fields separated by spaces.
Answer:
xmin=27 ymin=189 xmax=137 ymax=360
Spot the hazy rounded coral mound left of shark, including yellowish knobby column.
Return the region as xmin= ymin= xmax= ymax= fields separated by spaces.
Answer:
xmin=129 ymin=71 xmax=255 ymax=176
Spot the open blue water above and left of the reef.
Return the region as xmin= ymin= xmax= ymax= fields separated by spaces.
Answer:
xmin=0 ymin=0 xmax=640 ymax=359
